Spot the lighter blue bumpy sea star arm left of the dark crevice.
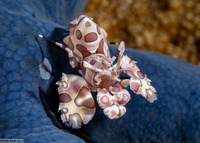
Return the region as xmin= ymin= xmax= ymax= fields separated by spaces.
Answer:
xmin=0 ymin=0 xmax=86 ymax=143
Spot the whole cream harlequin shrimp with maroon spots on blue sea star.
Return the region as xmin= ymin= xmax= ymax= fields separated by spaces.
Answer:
xmin=39 ymin=15 xmax=157 ymax=129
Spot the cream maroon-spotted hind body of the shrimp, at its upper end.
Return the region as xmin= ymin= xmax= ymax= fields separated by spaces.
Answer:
xmin=64 ymin=15 xmax=111 ymax=67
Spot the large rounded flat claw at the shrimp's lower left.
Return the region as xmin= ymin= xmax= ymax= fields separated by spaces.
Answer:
xmin=58 ymin=73 xmax=96 ymax=128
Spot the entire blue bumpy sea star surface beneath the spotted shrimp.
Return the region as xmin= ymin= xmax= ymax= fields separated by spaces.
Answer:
xmin=0 ymin=0 xmax=200 ymax=143
